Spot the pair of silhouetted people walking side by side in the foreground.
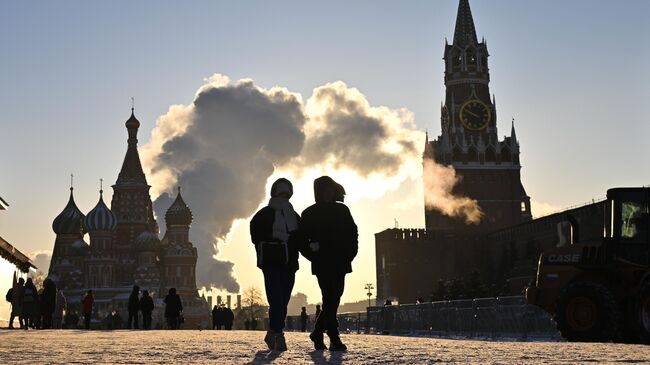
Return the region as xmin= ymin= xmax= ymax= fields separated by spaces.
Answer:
xmin=250 ymin=176 xmax=358 ymax=351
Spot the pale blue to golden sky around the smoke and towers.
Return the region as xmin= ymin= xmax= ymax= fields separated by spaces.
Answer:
xmin=0 ymin=0 xmax=650 ymax=312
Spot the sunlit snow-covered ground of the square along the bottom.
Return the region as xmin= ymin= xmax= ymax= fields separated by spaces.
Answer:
xmin=0 ymin=330 xmax=650 ymax=364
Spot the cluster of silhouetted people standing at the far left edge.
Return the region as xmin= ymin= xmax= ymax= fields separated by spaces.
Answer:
xmin=5 ymin=278 xmax=66 ymax=330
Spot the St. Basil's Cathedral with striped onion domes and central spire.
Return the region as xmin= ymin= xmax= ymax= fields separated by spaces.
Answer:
xmin=48 ymin=109 xmax=210 ymax=328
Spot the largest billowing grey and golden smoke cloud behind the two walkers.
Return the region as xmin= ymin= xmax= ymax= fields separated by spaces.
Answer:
xmin=141 ymin=74 xmax=454 ymax=292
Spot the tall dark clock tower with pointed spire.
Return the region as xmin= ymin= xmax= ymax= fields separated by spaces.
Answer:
xmin=424 ymin=0 xmax=531 ymax=231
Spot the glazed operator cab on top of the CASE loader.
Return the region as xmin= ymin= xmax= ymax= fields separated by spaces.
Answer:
xmin=607 ymin=188 xmax=650 ymax=266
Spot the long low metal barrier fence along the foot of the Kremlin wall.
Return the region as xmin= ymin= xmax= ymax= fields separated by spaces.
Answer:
xmin=287 ymin=296 xmax=561 ymax=340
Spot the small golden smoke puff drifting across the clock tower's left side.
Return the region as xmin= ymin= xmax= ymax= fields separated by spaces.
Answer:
xmin=423 ymin=160 xmax=483 ymax=224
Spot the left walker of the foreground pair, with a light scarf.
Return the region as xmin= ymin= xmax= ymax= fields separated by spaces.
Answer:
xmin=250 ymin=178 xmax=300 ymax=351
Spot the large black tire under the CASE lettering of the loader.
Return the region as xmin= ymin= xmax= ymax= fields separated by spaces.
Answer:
xmin=555 ymin=281 xmax=621 ymax=342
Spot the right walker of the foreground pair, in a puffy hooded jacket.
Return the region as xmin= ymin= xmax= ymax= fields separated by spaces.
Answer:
xmin=301 ymin=176 xmax=358 ymax=351
